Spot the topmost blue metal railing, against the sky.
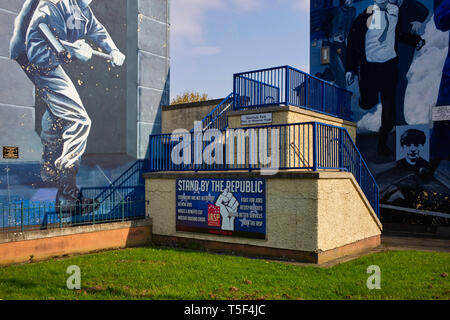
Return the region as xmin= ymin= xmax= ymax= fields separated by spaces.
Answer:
xmin=233 ymin=66 xmax=352 ymax=121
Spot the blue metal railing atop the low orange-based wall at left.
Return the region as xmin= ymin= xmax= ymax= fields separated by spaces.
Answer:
xmin=0 ymin=160 xmax=148 ymax=233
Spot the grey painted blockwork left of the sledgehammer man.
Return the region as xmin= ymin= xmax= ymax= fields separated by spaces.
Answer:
xmin=0 ymin=0 xmax=42 ymax=162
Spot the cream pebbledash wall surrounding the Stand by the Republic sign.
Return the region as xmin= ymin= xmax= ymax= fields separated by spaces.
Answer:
xmin=145 ymin=172 xmax=382 ymax=263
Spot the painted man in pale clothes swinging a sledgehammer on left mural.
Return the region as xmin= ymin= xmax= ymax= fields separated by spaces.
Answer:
xmin=10 ymin=0 xmax=125 ymax=213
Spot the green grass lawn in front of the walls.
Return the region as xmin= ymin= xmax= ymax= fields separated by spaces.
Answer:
xmin=0 ymin=247 xmax=450 ymax=300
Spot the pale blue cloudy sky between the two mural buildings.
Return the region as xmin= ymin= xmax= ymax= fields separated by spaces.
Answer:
xmin=170 ymin=0 xmax=310 ymax=100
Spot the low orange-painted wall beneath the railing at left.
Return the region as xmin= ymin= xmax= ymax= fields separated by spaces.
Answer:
xmin=0 ymin=219 xmax=152 ymax=265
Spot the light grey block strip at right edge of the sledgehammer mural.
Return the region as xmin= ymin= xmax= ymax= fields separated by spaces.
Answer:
xmin=134 ymin=0 xmax=170 ymax=159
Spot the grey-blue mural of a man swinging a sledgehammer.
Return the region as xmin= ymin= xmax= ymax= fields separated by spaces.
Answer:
xmin=0 ymin=0 xmax=170 ymax=213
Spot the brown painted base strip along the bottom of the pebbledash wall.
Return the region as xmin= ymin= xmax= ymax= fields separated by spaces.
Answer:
xmin=152 ymin=235 xmax=381 ymax=264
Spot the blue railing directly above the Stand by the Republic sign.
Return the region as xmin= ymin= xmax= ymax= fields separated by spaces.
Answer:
xmin=149 ymin=122 xmax=379 ymax=215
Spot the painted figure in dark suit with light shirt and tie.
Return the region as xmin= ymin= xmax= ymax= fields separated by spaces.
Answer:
xmin=346 ymin=0 xmax=420 ymax=156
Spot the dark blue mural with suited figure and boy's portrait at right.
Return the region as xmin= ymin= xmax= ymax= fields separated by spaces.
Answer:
xmin=311 ymin=0 xmax=450 ymax=218
